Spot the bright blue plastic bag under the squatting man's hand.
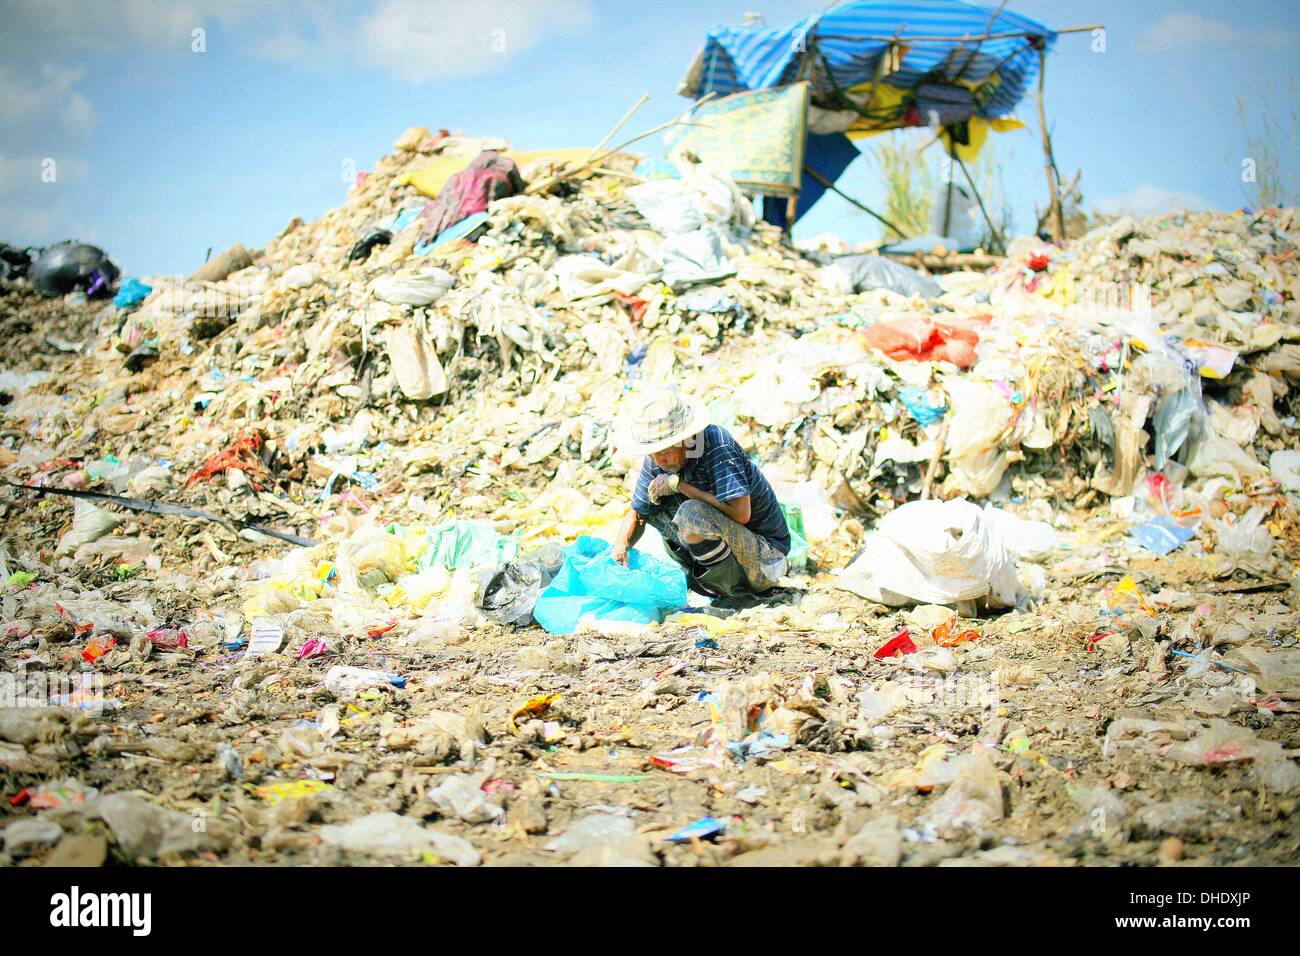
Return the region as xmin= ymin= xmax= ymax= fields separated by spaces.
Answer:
xmin=533 ymin=535 xmax=686 ymax=633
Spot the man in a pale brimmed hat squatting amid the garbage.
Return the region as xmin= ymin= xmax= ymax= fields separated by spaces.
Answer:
xmin=611 ymin=392 xmax=790 ymax=597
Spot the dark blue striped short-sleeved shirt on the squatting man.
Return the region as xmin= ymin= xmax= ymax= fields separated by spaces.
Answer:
xmin=632 ymin=425 xmax=790 ymax=554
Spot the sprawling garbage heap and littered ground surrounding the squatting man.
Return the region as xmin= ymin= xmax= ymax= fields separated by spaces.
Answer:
xmin=0 ymin=127 xmax=1300 ymax=865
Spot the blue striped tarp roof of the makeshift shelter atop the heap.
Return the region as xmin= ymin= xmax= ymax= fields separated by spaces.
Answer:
xmin=681 ymin=0 xmax=1056 ymax=118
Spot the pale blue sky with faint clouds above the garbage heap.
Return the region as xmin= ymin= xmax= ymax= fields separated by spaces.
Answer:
xmin=0 ymin=0 xmax=1300 ymax=273
